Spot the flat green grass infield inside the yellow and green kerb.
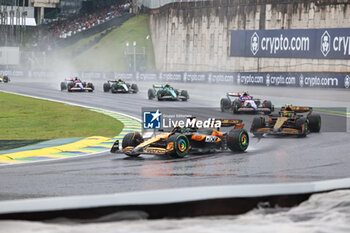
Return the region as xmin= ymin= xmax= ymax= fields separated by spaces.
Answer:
xmin=0 ymin=92 xmax=124 ymax=140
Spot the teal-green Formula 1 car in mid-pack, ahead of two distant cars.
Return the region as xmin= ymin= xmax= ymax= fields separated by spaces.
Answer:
xmin=148 ymin=84 xmax=190 ymax=101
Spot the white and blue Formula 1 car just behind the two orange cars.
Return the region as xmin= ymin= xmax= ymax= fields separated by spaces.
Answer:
xmin=220 ymin=92 xmax=274 ymax=114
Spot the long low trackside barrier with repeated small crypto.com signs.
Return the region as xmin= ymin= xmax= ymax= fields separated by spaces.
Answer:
xmin=0 ymin=70 xmax=350 ymax=89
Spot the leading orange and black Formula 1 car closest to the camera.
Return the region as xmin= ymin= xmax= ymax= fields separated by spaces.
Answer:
xmin=111 ymin=119 xmax=249 ymax=158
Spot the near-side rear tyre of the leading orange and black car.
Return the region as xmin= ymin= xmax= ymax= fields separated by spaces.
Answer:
xmin=227 ymin=129 xmax=249 ymax=152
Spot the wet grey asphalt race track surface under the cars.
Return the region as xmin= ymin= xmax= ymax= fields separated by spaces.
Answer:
xmin=0 ymin=80 xmax=350 ymax=200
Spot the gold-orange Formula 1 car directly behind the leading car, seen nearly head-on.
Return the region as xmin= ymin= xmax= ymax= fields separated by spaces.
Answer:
xmin=250 ymin=104 xmax=321 ymax=137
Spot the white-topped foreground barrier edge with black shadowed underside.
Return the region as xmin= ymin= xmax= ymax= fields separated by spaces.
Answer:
xmin=0 ymin=178 xmax=350 ymax=222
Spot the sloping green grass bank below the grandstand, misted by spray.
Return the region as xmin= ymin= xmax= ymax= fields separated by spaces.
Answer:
xmin=72 ymin=15 xmax=154 ymax=72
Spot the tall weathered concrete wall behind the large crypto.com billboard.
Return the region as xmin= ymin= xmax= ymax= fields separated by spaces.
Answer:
xmin=150 ymin=0 xmax=350 ymax=72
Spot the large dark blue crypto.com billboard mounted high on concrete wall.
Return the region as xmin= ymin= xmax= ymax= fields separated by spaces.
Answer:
xmin=230 ymin=28 xmax=350 ymax=59
